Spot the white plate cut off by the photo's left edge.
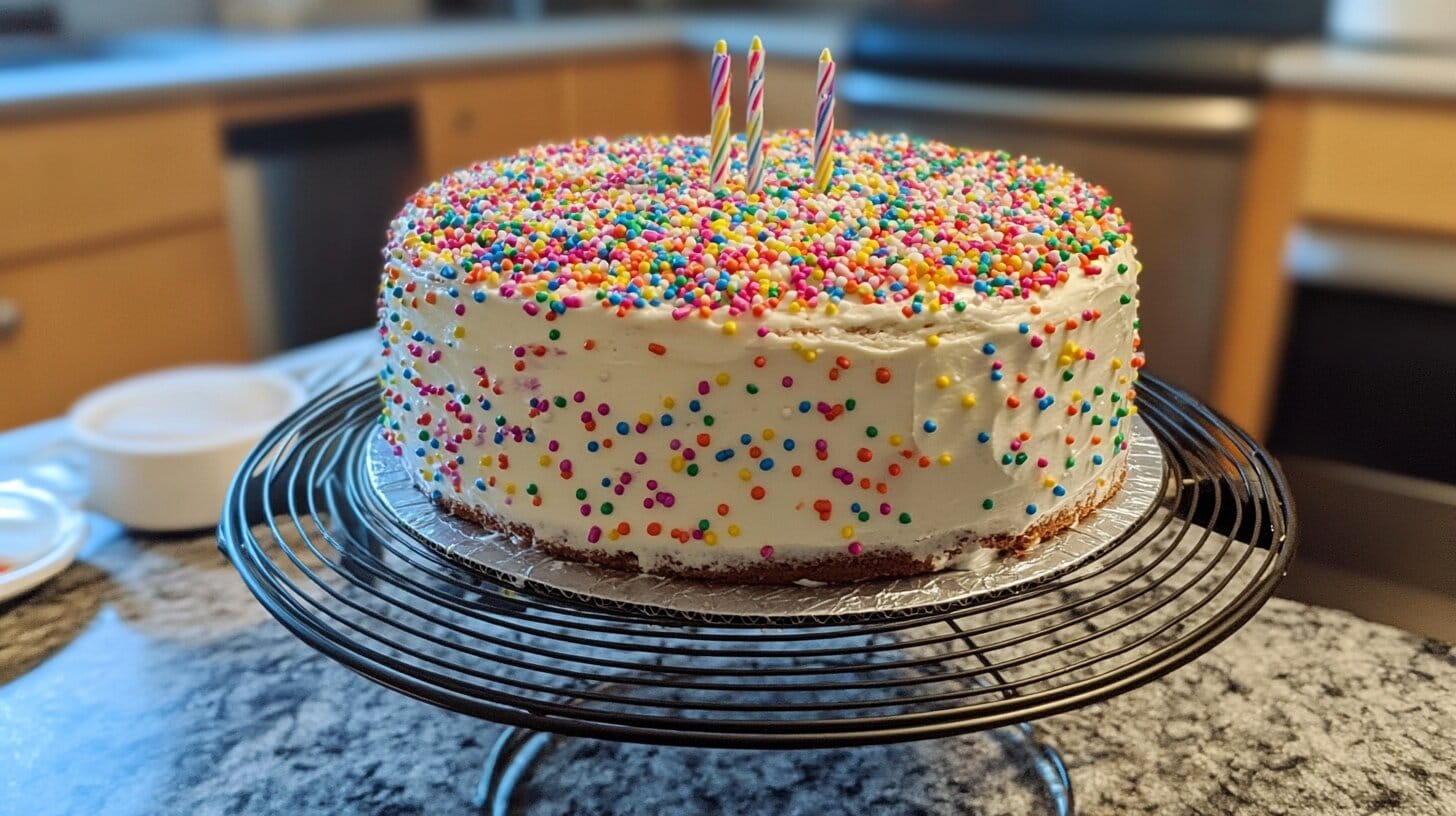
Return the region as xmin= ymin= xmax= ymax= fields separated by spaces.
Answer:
xmin=0 ymin=479 xmax=86 ymax=602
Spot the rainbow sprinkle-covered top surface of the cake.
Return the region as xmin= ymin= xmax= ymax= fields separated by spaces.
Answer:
xmin=384 ymin=131 xmax=1131 ymax=319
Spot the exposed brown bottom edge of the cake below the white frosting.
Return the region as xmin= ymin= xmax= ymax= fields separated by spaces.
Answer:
xmin=435 ymin=462 xmax=1127 ymax=584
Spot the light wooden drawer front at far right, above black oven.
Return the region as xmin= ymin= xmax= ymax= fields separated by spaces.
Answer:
xmin=1302 ymin=99 xmax=1456 ymax=235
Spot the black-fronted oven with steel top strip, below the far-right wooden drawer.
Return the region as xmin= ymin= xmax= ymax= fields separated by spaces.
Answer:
xmin=1268 ymin=227 xmax=1456 ymax=620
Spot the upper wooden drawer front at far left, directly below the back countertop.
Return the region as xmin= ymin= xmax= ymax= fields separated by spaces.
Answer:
xmin=0 ymin=106 xmax=223 ymax=260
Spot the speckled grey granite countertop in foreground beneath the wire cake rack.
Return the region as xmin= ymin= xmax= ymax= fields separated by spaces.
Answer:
xmin=0 ymin=522 xmax=1456 ymax=816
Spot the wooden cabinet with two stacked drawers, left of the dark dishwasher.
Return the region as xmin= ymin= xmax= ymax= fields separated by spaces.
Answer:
xmin=0 ymin=103 xmax=245 ymax=427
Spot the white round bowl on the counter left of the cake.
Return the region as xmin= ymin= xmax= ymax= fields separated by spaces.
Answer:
xmin=70 ymin=366 xmax=304 ymax=530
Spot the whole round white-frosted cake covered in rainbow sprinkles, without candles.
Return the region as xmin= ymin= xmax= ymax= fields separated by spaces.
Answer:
xmin=379 ymin=131 xmax=1142 ymax=583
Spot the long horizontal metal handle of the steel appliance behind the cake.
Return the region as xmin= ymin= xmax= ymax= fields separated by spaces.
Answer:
xmin=839 ymin=71 xmax=1258 ymax=138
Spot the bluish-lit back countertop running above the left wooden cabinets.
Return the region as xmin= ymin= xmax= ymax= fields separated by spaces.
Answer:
xmin=0 ymin=13 xmax=847 ymax=117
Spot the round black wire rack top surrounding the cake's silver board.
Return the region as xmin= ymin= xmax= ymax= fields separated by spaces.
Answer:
xmin=218 ymin=376 xmax=1294 ymax=748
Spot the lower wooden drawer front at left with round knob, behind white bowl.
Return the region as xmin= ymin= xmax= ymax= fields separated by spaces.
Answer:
xmin=0 ymin=226 xmax=246 ymax=428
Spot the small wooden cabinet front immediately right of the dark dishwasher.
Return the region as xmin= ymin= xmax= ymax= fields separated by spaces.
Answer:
xmin=415 ymin=66 xmax=572 ymax=178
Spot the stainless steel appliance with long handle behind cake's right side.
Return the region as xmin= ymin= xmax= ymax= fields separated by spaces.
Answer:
xmin=840 ymin=0 xmax=1322 ymax=398
